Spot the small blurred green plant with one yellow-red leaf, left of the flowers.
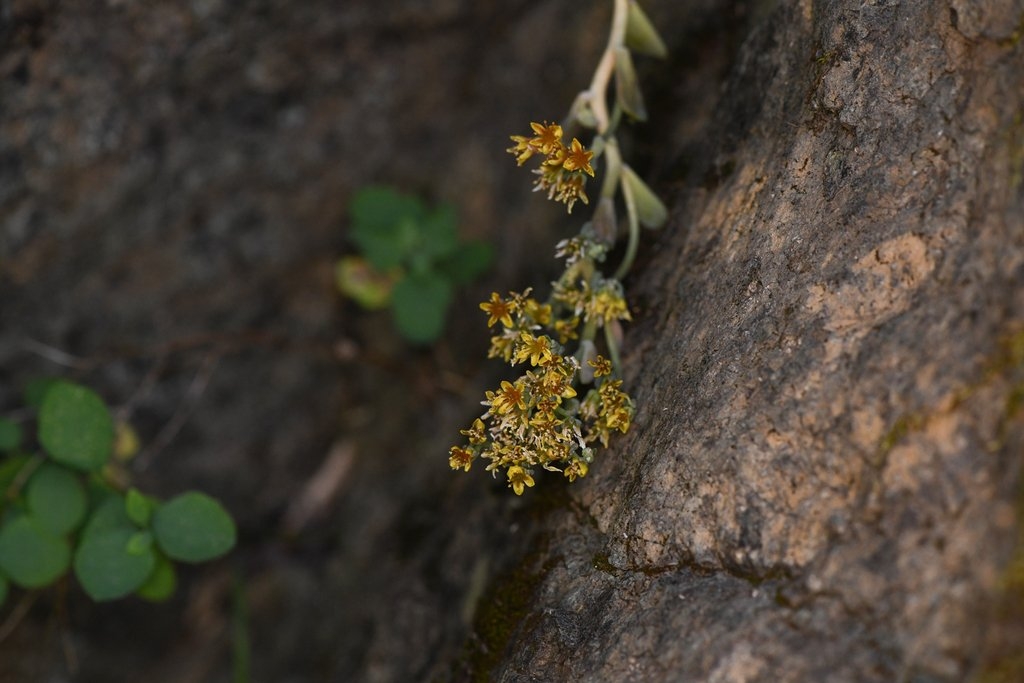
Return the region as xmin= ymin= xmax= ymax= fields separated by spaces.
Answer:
xmin=335 ymin=186 xmax=494 ymax=344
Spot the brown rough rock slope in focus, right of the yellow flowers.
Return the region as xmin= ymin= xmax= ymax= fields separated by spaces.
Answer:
xmin=498 ymin=2 xmax=1024 ymax=681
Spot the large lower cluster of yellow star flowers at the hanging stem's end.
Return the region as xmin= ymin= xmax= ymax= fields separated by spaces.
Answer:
xmin=449 ymin=239 xmax=633 ymax=495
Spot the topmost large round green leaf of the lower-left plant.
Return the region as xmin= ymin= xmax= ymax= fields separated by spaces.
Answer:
xmin=39 ymin=382 xmax=114 ymax=472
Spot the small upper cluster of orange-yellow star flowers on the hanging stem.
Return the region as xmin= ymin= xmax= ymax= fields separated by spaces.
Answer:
xmin=508 ymin=123 xmax=594 ymax=213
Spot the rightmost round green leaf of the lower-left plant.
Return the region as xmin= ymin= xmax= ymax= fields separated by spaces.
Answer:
xmin=153 ymin=492 xmax=236 ymax=562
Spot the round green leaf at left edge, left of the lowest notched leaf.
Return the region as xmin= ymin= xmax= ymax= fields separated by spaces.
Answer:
xmin=0 ymin=515 xmax=71 ymax=588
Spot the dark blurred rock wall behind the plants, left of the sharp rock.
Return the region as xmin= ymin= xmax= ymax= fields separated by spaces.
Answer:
xmin=0 ymin=0 xmax=720 ymax=682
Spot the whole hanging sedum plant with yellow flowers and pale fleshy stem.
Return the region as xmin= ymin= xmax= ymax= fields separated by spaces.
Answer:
xmin=449 ymin=0 xmax=668 ymax=496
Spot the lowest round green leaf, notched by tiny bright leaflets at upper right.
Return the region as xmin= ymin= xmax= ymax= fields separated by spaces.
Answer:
xmin=75 ymin=527 xmax=157 ymax=602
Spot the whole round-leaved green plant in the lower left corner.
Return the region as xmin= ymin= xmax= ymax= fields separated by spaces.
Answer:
xmin=0 ymin=381 xmax=236 ymax=605
